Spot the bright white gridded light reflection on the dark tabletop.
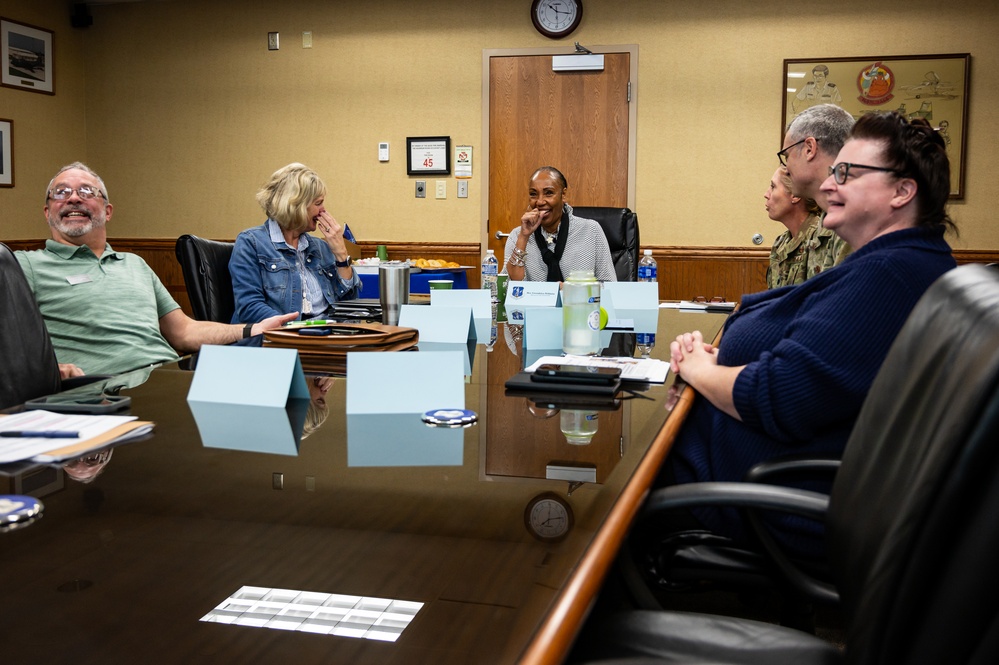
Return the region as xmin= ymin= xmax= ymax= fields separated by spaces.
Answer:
xmin=201 ymin=586 xmax=423 ymax=642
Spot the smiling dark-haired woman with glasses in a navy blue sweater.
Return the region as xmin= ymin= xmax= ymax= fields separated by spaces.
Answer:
xmin=667 ymin=113 xmax=956 ymax=556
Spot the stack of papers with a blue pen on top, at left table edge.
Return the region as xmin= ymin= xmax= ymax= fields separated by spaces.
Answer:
xmin=0 ymin=409 xmax=154 ymax=464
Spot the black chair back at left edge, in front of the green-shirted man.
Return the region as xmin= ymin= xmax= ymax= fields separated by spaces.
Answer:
xmin=0 ymin=243 xmax=60 ymax=409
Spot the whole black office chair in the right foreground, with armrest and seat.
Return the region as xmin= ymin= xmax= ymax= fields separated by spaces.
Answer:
xmin=576 ymin=265 xmax=999 ymax=665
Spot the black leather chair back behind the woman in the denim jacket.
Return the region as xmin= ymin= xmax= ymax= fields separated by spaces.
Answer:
xmin=177 ymin=235 xmax=236 ymax=323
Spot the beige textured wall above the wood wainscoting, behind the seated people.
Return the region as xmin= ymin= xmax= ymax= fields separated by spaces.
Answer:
xmin=0 ymin=0 xmax=999 ymax=250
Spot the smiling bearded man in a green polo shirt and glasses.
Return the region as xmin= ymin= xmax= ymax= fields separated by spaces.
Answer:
xmin=16 ymin=162 xmax=298 ymax=378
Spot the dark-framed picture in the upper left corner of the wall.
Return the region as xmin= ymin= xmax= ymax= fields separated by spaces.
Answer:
xmin=0 ymin=18 xmax=55 ymax=95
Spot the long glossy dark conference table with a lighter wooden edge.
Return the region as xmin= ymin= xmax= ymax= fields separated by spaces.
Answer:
xmin=0 ymin=309 xmax=725 ymax=665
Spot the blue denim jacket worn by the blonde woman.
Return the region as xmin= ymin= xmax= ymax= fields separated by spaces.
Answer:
xmin=229 ymin=222 xmax=361 ymax=323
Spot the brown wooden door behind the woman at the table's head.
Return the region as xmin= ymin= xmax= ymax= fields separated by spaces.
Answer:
xmin=487 ymin=53 xmax=631 ymax=254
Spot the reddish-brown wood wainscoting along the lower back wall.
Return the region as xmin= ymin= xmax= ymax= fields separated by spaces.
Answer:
xmin=4 ymin=238 xmax=999 ymax=314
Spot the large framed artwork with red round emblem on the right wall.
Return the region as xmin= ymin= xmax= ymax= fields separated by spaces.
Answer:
xmin=781 ymin=53 xmax=971 ymax=199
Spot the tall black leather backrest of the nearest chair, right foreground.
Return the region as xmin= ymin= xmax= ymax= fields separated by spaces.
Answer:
xmin=826 ymin=265 xmax=999 ymax=664
